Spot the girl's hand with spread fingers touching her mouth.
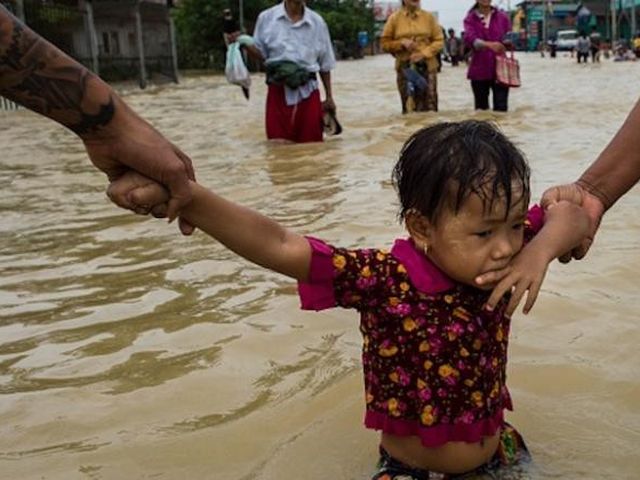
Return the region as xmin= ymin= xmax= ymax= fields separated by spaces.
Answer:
xmin=485 ymin=245 xmax=549 ymax=317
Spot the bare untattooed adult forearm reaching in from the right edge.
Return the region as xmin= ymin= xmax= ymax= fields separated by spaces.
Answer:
xmin=578 ymin=101 xmax=640 ymax=209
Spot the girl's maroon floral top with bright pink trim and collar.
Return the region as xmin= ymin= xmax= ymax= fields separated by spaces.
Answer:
xmin=298 ymin=206 xmax=543 ymax=447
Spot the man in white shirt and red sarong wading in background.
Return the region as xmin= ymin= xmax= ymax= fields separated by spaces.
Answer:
xmin=242 ymin=0 xmax=336 ymax=142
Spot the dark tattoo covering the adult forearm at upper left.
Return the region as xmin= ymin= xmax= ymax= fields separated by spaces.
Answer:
xmin=0 ymin=6 xmax=115 ymax=134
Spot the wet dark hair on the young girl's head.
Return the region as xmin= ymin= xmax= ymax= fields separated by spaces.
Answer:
xmin=393 ymin=120 xmax=530 ymax=223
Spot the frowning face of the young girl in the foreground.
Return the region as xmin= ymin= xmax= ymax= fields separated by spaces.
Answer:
xmin=407 ymin=186 xmax=526 ymax=290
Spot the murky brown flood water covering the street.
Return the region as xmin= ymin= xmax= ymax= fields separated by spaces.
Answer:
xmin=0 ymin=54 xmax=640 ymax=480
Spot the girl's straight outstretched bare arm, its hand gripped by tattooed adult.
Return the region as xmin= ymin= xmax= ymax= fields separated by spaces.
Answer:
xmin=107 ymin=172 xmax=311 ymax=281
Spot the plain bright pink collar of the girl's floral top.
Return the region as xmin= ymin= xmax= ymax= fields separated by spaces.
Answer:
xmin=391 ymin=238 xmax=455 ymax=295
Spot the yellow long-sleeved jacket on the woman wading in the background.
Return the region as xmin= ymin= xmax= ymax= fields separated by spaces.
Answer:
xmin=380 ymin=7 xmax=444 ymax=72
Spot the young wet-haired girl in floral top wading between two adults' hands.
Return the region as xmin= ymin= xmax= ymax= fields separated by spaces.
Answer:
xmin=110 ymin=121 xmax=589 ymax=480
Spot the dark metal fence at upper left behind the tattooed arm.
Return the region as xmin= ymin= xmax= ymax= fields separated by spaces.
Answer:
xmin=0 ymin=0 xmax=178 ymax=110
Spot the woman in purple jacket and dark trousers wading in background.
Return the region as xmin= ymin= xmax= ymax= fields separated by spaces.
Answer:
xmin=464 ymin=0 xmax=511 ymax=112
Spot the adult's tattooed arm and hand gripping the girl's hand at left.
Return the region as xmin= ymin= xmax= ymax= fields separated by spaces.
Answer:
xmin=0 ymin=5 xmax=194 ymax=233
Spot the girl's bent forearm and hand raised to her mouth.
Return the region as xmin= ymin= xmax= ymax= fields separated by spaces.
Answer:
xmin=486 ymin=201 xmax=591 ymax=316
